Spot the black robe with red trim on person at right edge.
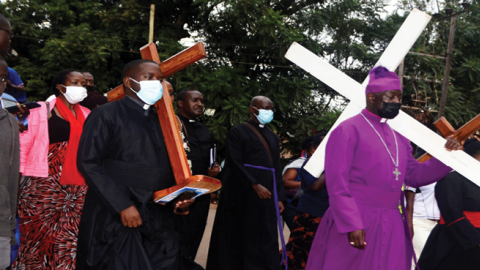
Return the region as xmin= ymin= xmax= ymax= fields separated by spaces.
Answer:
xmin=419 ymin=172 xmax=480 ymax=270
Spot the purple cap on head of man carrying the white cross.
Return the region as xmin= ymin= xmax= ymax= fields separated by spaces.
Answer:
xmin=365 ymin=66 xmax=402 ymax=94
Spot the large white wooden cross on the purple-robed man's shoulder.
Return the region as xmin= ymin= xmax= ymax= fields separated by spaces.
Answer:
xmin=285 ymin=9 xmax=480 ymax=186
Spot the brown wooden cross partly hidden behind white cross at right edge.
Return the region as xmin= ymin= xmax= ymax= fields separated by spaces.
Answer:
xmin=418 ymin=114 xmax=480 ymax=163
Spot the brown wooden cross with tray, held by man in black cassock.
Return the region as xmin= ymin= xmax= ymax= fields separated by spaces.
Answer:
xmin=107 ymin=42 xmax=222 ymax=202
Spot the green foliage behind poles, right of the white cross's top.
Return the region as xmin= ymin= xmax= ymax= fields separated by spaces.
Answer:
xmin=394 ymin=1 xmax=480 ymax=128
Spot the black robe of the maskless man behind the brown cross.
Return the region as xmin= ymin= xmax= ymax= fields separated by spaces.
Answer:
xmin=175 ymin=114 xmax=213 ymax=260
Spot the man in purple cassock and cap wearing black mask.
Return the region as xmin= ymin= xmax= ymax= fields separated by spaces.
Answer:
xmin=306 ymin=67 xmax=462 ymax=270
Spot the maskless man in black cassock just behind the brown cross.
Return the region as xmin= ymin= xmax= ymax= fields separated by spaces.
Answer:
xmin=175 ymin=90 xmax=220 ymax=260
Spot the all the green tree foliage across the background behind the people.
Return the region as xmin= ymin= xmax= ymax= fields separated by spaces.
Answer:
xmin=0 ymin=0 xmax=480 ymax=159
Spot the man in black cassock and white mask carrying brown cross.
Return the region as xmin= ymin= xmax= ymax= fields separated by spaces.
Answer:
xmin=77 ymin=60 xmax=192 ymax=270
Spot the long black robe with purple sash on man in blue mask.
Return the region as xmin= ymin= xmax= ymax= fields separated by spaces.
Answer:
xmin=207 ymin=121 xmax=286 ymax=270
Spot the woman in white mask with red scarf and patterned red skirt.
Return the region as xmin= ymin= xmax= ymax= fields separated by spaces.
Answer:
xmin=13 ymin=70 xmax=90 ymax=270
